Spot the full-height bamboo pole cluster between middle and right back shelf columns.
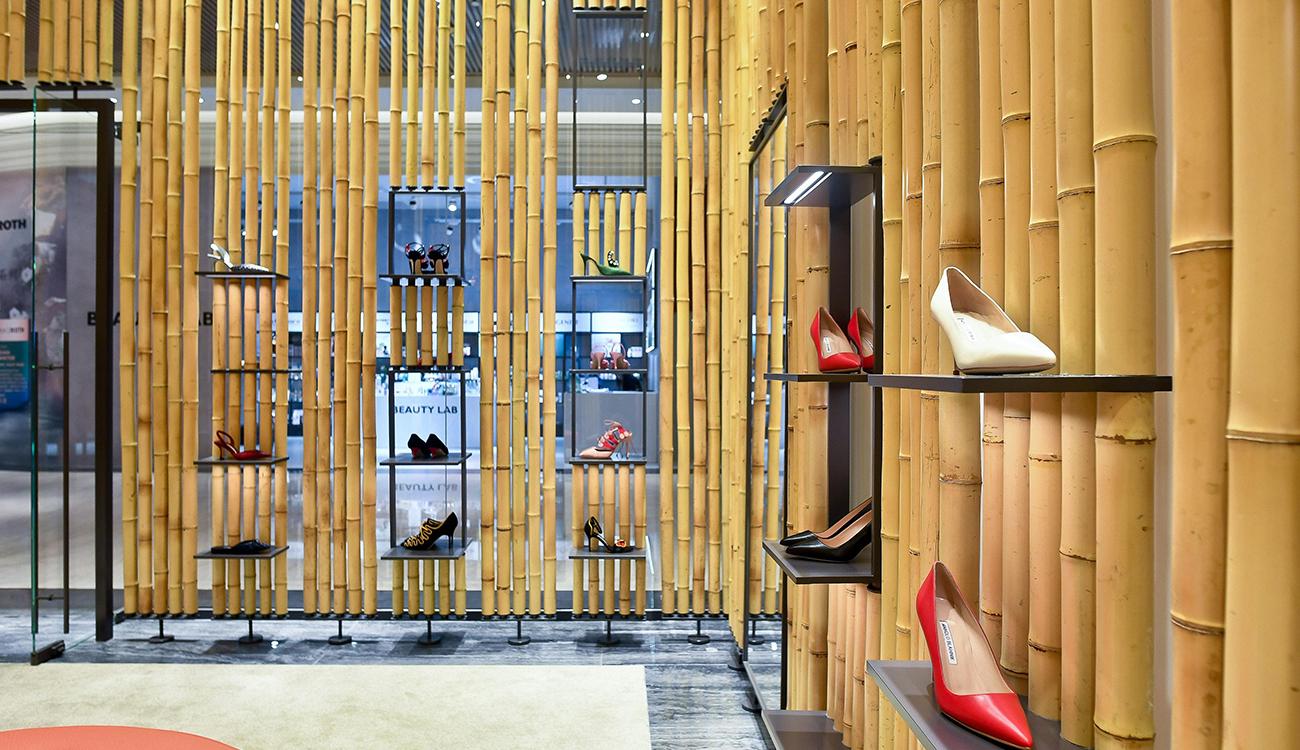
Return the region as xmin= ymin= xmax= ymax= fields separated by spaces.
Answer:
xmin=478 ymin=0 xmax=559 ymax=615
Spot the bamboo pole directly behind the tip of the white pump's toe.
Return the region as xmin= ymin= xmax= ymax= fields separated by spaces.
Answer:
xmin=1028 ymin=0 xmax=1061 ymax=719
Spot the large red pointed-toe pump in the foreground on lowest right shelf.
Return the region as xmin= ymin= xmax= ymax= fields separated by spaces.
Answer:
xmin=917 ymin=563 xmax=1034 ymax=750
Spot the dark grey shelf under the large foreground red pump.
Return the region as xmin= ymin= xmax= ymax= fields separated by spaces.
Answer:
xmin=867 ymin=660 xmax=1080 ymax=750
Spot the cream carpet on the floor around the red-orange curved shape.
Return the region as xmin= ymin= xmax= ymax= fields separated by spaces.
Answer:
xmin=0 ymin=663 xmax=650 ymax=750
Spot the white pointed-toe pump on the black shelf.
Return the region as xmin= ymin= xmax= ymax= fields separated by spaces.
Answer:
xmin=930 ymin=266 xmax=1056 ymax=374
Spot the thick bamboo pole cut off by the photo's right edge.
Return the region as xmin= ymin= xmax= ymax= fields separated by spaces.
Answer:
xmin=1222 ymin=0 xmax=1300 ymax=749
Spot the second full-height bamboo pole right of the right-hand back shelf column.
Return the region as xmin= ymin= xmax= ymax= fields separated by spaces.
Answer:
xmin=672 ymin=0 xmax=694 ymax=612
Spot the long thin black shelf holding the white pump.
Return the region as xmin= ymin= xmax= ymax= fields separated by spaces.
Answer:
xmin=867 ymin=374 xmax=1174 ymax=394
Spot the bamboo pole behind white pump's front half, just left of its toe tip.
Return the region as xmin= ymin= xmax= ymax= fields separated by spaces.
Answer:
xmin=998 ymin=0 xmax=1030 ymax=693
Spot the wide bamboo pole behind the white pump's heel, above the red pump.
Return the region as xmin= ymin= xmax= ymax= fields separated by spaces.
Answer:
xmin=936 ymin=0 xmax=980 ymax=601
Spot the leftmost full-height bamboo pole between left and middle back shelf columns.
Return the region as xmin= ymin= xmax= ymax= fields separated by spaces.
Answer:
xmin=300 ymin=0 xmax=321 ymax=612
